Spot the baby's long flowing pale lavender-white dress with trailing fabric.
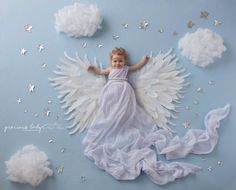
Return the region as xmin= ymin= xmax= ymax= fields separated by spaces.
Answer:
xmin=83 ymin=66 xmax=230 ymax=185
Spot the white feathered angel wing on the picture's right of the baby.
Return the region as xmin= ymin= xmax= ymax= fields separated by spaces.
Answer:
xmin=130 ymin=49 xmax=190 ymax=131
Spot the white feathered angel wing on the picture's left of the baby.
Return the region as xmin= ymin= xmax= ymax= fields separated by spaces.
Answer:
xmin=49 ymin=53 xmax=106 ymax=134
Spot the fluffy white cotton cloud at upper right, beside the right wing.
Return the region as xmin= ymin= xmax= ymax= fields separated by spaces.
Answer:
xmin=178 ymin=28 xmax=226 ymax=67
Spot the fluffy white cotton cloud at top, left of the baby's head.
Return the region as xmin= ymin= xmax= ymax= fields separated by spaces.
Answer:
xmin=55 ymin=3 xmax=102 ymax=37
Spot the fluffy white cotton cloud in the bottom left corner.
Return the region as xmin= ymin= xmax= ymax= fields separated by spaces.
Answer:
xmin=5 ymin=144 xmax=53 ymax=187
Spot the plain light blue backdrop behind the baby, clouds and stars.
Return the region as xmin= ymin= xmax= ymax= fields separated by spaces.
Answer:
xmin=0 ymin=0 xmax=236 ymax=190
